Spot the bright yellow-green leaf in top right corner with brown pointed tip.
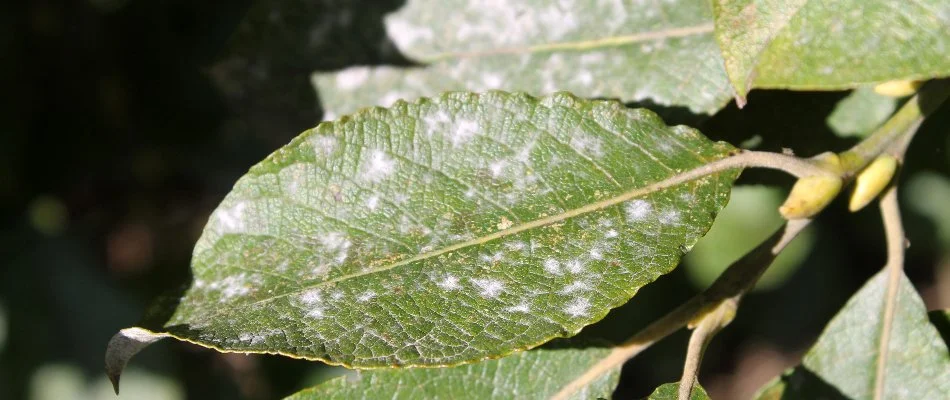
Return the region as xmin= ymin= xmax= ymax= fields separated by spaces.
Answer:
xmin=713 ymin=0 xmax=950 ymax=103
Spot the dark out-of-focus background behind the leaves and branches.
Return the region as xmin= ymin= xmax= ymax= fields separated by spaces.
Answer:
xmin=0 ymin=0 xmax=950 ymax=399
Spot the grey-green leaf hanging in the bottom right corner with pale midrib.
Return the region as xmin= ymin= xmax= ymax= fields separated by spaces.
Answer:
xmin=758 ymin=270 xmax=950 ymax=399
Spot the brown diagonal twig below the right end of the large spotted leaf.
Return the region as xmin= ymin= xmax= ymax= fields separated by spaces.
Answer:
xmin=552 ymin=219 xmax=811 ymax=399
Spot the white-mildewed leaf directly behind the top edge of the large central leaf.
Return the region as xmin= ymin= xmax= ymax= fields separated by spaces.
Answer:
xmin=313 ymin=0 xmax=732 ymax=115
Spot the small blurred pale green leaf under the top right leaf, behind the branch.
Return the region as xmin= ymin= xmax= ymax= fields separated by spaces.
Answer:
xmin=828 ymin=86 xmax=897 ymax=138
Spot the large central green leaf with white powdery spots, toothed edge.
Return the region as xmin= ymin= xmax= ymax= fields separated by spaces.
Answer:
xmin=108 ymin=92 xmax=736 ymax=374
